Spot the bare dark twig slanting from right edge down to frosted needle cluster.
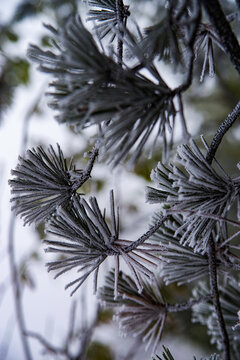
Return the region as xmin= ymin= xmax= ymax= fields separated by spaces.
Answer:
xmin=206 ymin=101 xmax=240 ymax=163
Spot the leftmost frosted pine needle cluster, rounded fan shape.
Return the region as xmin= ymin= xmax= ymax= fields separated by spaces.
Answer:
xmin=9 ymin=145 xmax=81 ymax=225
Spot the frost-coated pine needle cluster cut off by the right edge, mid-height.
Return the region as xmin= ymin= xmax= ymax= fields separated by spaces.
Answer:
xmin=147 ymin=141 xmax=240 ymax=253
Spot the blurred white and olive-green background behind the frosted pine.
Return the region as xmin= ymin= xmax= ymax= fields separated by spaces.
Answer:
xmin=0 ymin=0 xmax=240 ymax=360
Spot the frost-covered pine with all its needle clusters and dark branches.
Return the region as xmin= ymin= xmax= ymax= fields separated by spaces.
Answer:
xmin=10 ymin=0 xmax=240 ymax=360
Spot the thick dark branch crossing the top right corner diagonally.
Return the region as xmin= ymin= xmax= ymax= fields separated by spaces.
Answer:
xmin=202 ymin=0 xmax=240 ymax=74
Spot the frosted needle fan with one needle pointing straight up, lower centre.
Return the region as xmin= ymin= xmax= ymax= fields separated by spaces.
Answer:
xmin=45 ymin=191 xmax=161 ymax=297
